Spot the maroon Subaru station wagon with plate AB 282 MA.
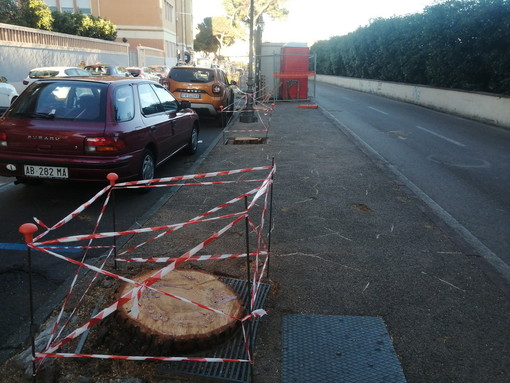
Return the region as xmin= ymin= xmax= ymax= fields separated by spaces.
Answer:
xmin=0 ymin=77 xmax=199 ymax=183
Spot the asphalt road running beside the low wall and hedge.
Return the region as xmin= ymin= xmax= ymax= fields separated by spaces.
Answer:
xmin=317 ymin=83 xmax=510 ymax=280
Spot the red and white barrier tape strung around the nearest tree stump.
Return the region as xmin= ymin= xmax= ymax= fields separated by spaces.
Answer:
xmin=27 ymin=166 xmax=275 ymax=362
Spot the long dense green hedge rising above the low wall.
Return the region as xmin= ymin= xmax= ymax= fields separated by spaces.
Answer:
xmin=311 ymin=0 xmax=510 ymax=93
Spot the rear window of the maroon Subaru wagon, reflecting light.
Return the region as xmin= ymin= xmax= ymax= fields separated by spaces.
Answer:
xmin=8 ymin=81 xmax=107 ymax=121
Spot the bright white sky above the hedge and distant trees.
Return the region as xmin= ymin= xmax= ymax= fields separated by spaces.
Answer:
xmin=193 ymin=0 xmax=435 ymax=46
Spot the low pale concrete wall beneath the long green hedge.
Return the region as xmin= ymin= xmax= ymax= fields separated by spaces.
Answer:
xmin=317 ymin=75 xmax=510 ymax=128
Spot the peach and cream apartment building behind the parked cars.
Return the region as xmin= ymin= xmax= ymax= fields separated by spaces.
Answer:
xmin=44 ymin=0 xmax=194 ymax=66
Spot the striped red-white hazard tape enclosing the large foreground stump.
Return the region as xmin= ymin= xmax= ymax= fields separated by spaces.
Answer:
xmin=20 ymin=165 xmax=276 ymax=363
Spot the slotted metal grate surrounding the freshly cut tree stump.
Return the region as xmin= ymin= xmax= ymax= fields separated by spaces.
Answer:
xmin=158 ymin=278 xmax=270 ymax=383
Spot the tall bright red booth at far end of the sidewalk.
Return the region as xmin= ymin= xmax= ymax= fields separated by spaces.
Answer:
xmin=280 ymin=43 xmax=310 ymax=100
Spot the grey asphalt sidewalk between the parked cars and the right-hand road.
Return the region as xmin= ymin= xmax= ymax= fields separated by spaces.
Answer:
xmin=1 ymin=103 xmax=510 ymax=383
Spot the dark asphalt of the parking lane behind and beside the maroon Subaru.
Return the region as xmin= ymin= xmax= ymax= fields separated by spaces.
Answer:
xmin=0 ymin=118 xmax=222 ymax=361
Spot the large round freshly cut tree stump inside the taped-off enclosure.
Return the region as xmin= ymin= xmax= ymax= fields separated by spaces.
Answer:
xmin=118 ymin=269 xmax=243 ymax=352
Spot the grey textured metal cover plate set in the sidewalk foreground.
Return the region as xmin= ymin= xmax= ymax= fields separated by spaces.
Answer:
xmin=282 ymin=314 xmax=406 ymax=383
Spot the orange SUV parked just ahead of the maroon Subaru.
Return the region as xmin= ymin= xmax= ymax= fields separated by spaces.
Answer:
xmin=168 ymin=66 xmax=236 ymax=124
